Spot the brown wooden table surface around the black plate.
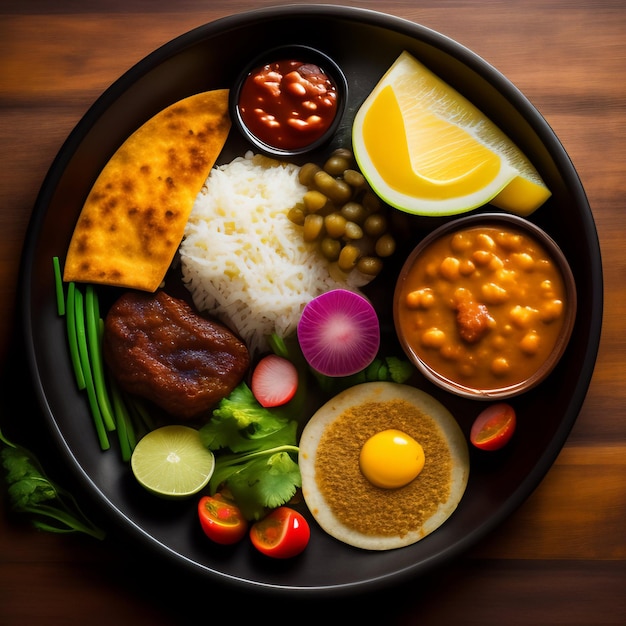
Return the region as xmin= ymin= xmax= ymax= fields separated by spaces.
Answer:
xmin=0 ymin=0 xmax=626 ymax=626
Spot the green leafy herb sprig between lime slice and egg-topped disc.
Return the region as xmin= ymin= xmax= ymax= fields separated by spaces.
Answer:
xmin=200 ymin=382 xmax=301 ymax=520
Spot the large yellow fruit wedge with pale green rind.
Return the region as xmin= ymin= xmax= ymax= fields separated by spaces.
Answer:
xmin=352 ymin=51 xmax=551 ymax=216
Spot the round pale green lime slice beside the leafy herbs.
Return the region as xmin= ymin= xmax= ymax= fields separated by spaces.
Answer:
xmin=130 ymin=425 xmax=215 ymax=499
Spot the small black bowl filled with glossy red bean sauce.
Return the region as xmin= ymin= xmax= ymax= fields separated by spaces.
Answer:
xmin=230 ymin=45 xmax=348 ymax=157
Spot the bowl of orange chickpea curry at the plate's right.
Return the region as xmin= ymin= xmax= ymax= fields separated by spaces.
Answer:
xmin=394 ymin=213 xmax=576 ymax=400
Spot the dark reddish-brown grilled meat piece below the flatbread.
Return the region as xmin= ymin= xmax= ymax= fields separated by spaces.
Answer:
xmin=103 ymin=291 xmax=250 ymax=420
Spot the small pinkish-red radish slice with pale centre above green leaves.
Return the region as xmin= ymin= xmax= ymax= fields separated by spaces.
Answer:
xmin=250 ymin=354 xmax=298 ymax=408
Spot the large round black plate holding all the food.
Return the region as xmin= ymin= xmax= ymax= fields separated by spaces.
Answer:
xmin=20 ymin=5 xmax=602 ymax=595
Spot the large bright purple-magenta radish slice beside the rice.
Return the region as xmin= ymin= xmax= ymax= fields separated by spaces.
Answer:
xmin=297 ymin=289 xmax=380 ymax=376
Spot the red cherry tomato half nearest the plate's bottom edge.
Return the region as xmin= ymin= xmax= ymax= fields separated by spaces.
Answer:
xmin=250 ymin=506 xmax=311 ymax=559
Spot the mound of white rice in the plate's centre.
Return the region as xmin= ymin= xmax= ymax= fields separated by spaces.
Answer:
xmin=180 ymin=152 xmax=346 ymax=352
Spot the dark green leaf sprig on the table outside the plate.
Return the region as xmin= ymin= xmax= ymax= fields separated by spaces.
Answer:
xmin=0 ymin=431 xmax=105 ymax=539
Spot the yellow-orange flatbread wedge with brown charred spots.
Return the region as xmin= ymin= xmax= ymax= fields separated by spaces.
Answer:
xmin=63 ymin=89 xmax=231 ymax=292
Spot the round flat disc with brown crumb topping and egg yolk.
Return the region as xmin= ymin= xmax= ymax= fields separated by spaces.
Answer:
xmin=298 ymin=382 xmax=469 ymax=550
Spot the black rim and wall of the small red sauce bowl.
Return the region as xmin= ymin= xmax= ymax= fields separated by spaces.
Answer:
xmin=229 ymin=44 xmax=348 ymax=158
